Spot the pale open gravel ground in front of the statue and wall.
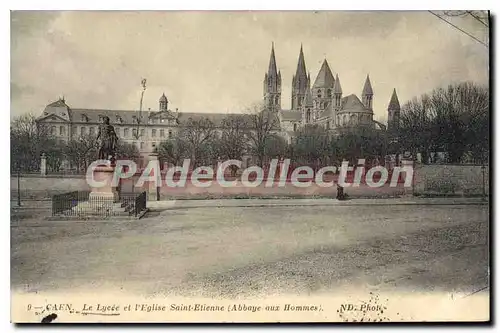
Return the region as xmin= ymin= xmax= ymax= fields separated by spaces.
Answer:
xmin=11 ymin=205 xmax=489 ymax=298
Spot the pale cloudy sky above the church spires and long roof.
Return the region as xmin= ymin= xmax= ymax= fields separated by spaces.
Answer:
xmin=11 ymin=11 xmax=489 ymax=120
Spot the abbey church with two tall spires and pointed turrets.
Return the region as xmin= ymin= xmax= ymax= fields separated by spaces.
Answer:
xmin=264 ymin=44 xmax=401 ymax=135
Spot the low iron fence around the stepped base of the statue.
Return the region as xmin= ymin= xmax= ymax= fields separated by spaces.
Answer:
xmin=52 ymin=191 xmax=146 ymax=219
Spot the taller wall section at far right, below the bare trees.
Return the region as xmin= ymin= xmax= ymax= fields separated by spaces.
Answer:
xmin=413 ymin=164 xmax=489 ymax=196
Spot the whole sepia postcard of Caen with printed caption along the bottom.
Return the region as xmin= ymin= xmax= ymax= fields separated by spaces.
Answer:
xmin=10 ymin=10 xmax=491 ymax=324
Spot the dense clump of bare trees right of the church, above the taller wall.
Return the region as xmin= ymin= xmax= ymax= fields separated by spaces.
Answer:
xmin=399 ymin=82 xmax=490 ymax=163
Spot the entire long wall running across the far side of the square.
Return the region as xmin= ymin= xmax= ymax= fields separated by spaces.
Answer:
xmin=10 ymin=164 xmax=489 ymax=199
